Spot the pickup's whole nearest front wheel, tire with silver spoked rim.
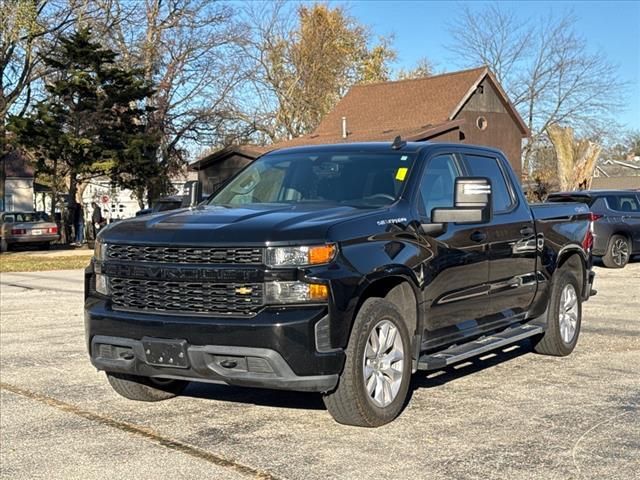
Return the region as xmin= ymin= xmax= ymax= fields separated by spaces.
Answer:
xmin=324 ymin=298 xmax=411 ymax=427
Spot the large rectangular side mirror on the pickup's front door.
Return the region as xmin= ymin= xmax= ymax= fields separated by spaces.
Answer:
xmin=431 ymin=177 xmax=492 ymax=223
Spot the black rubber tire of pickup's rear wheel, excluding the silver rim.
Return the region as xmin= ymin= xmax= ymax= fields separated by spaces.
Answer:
xmin=535 ymin=270 xmax=582 ymax=357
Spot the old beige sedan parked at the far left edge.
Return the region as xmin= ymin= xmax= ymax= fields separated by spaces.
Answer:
xmin=0 ymin=212 xmax=60 ymax=252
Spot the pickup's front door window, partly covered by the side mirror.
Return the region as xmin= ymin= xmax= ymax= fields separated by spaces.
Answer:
xmin=420 ymin=155 xmax=459 ymax=217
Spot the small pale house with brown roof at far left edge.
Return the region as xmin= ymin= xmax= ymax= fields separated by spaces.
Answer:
xmin=0 ymin=150 xmax=34 ymax=212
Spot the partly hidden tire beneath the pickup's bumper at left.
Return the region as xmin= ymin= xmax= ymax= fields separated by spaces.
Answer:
xmin=107 ymin=372 xmax=189 ymax=402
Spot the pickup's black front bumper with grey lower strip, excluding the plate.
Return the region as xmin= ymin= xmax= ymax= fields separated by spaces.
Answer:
xmin=85 ymin=297 xmax=344 ymax=392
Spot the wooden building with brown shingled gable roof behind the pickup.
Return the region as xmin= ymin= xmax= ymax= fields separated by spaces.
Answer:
xmin=190 ymin=67 xmax=530 ymax=191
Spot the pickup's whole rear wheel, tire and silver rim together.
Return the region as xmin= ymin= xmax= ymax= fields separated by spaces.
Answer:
xmin=535 ymin=271 xmax=582 ymax=357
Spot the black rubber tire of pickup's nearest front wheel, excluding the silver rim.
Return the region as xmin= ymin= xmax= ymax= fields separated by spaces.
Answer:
xmin=323 ymin=298 xmax=411 ymax=427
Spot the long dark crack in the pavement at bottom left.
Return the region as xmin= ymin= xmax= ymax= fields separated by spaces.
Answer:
xmin=0 ymin=382 xmax=278 ymax=480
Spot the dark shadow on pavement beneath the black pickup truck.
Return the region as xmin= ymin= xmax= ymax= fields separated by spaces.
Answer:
xmin=182 ymin=340 xmax=533 ymax=410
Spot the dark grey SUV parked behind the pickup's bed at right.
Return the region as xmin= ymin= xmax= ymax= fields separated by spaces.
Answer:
xmin=547 ymin=190 xmax=640 ymax=268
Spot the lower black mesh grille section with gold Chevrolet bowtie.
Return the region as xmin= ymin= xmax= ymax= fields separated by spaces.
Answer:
xmin=109 ymin=277 xmax=263 ymax=316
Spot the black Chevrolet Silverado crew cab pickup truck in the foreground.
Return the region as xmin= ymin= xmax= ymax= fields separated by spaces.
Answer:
xmin=85 ymin=140 xmax=594 ymax=426
